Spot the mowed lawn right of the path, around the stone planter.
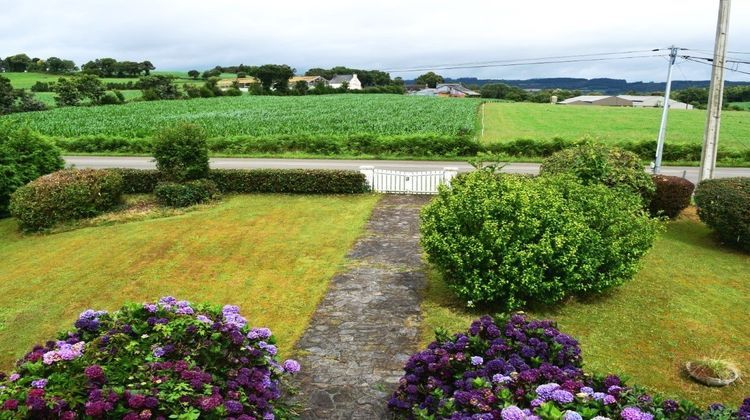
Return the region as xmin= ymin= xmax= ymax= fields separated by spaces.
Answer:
xmin=423 ymin=213 xmax=750 ymax=406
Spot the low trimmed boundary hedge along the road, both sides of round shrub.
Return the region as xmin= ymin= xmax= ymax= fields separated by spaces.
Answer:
xmin=112 ymin=169 xmax=369 ymax=194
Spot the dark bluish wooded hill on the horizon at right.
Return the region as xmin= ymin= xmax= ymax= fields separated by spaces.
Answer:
xmin=418 ymin=77 xmax=750 ymax=95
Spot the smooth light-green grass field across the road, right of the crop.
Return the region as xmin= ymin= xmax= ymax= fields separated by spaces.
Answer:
xmin=483 ymin=103 xmax=750 ymax=150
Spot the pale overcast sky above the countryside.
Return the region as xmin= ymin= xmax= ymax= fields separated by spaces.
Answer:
xmin=0 ymin=0 xmax=750 ymax=81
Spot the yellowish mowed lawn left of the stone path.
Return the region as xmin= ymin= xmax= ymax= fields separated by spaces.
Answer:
xmin=0 ymin=195 xmax=378 ymax=371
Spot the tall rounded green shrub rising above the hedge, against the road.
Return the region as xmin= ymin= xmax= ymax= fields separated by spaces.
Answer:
xmin=154 ymin=123 xmax=208 ymax=182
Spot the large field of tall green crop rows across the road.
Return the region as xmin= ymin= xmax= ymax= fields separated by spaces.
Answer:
xmin=0 ymin=94 xmax=479 ymax=138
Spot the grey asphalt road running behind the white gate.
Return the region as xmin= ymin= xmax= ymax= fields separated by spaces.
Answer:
xmin=65 ymin=156 xmax=750 ymax=182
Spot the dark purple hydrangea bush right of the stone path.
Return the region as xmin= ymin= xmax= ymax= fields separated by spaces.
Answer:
xmin=388 ymin=314 xmax=750 ymax=420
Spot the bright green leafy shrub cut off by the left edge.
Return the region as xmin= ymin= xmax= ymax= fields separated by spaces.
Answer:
xmin=0 ymin=124 xmax=64 ymax=217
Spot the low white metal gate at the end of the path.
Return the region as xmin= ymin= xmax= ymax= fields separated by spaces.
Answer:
xmin=360 ymin=166 xmax=458 ymax=194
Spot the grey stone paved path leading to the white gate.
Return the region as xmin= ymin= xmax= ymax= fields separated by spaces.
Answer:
xmin=297 ymin=195 xmax=430 ymax=419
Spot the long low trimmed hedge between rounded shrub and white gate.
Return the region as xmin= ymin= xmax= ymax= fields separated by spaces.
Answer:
xmin=209 ymin=169 xmax=369 ymax=194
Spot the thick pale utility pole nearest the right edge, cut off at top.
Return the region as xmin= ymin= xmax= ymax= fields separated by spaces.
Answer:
xmin=700 ymin=0 xmax=731 ymax=181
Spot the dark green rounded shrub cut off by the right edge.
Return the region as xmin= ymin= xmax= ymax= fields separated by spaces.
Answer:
xmin=695 ymin=178 xmax=750 ymax=252
